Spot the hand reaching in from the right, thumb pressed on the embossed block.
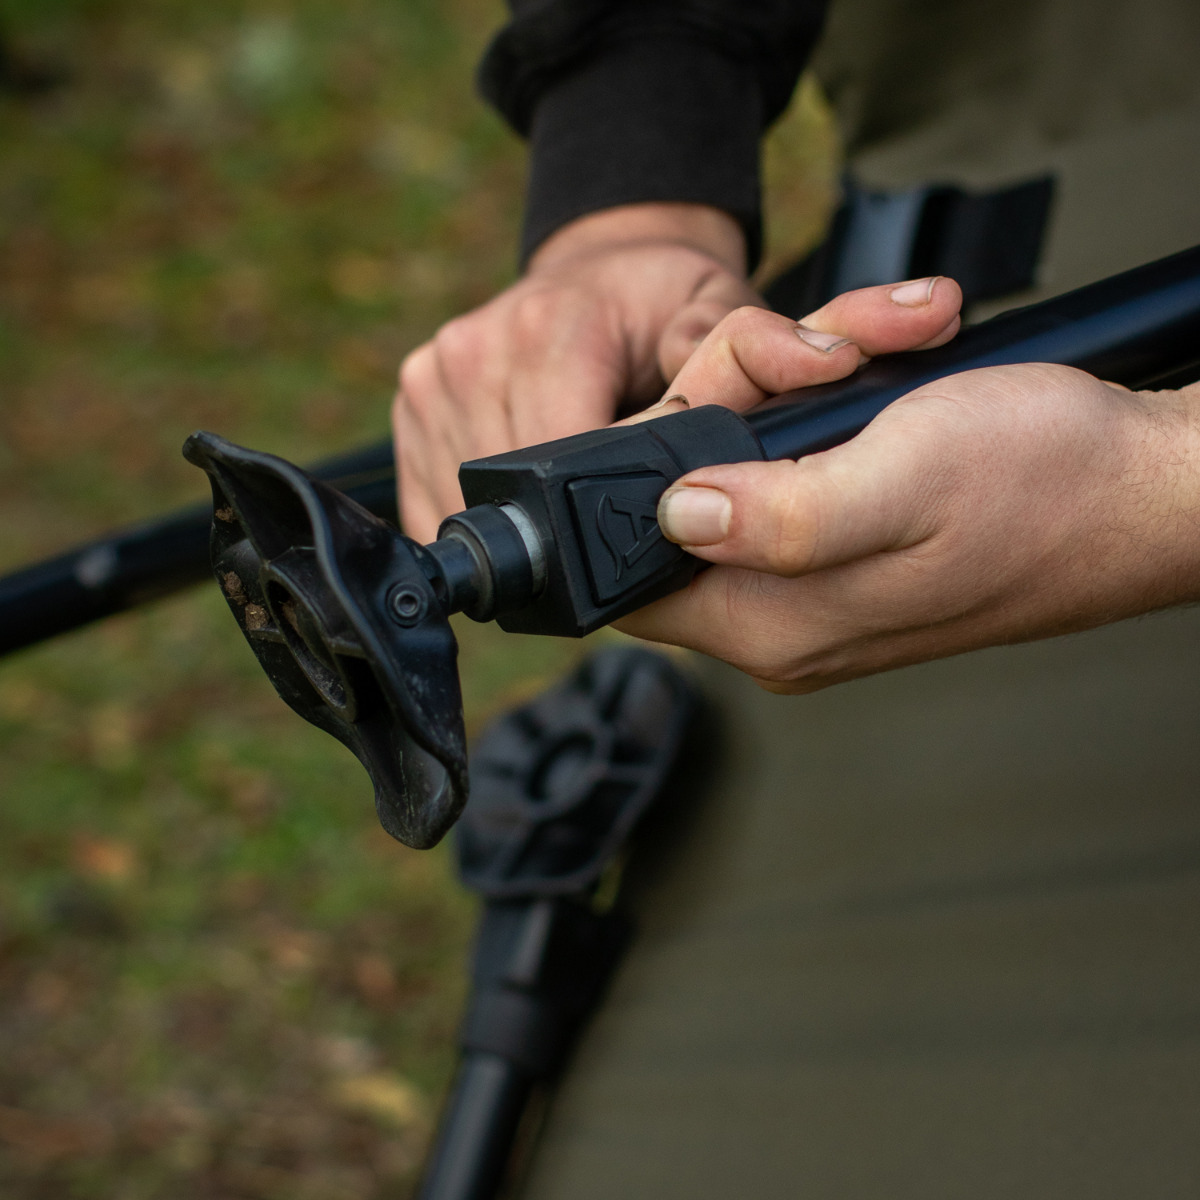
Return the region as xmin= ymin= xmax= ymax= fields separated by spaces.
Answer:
xmin=618 ymin=302 xmax=1200 ymax=692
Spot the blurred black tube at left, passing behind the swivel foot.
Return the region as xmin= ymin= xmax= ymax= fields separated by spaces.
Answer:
xmin=0 ymin=442 xmax=396 ymax=654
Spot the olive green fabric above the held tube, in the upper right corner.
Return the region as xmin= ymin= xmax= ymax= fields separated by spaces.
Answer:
xmin=815 ymin=0 xmax=1200 ymax=304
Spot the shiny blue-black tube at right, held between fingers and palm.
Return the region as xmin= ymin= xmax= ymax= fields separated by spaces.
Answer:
xmin=748 ymin=246 xmax=1200 ymax=458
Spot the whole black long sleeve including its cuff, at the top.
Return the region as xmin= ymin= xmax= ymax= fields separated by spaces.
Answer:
xmin=480 ymin=0 xmax=826 ymax=265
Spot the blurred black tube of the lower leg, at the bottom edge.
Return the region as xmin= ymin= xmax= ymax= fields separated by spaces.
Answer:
xmin=416 ymin=1050 xmax=533 ymax=1200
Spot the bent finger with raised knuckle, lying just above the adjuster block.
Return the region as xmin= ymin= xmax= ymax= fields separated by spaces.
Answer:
xmin=668 ymin=307 xmax=863 ymax=412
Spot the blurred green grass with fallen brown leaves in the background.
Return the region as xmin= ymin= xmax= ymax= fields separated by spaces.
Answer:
xmin=0 ymin=0 xmax=833 ymax=1200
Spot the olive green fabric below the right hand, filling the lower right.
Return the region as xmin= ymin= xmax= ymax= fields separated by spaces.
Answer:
xmin=526 ymin=612 xmax=1200 ymax=1200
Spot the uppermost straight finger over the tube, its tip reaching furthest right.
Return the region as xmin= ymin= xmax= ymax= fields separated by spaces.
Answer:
xmin=800 ymin=276 xmax=962 ymax=358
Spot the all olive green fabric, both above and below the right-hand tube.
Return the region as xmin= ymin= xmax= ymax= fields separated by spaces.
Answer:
xmin=521 ymin=0 xmax=1200 ymax=1200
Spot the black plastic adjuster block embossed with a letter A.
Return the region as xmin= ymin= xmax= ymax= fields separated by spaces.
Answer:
xmin=458 ymin=404 xmax=766 ymax=637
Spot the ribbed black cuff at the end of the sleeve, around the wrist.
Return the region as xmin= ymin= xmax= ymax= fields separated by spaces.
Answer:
xmin=521 ymin=37 xmax=763 ymax=270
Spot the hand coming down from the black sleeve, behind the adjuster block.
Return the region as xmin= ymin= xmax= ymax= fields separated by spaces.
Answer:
xmin=392 ymin=204 xmax=762 ymax=541
